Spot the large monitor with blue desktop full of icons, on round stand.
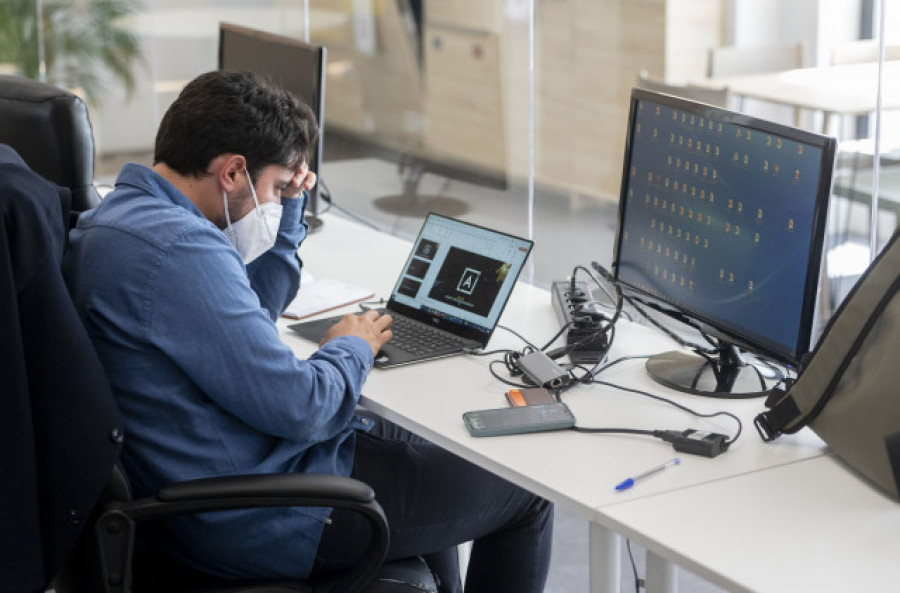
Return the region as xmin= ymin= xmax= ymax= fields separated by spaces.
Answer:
xmin=613 ymin=89 xmax=836 ymax=396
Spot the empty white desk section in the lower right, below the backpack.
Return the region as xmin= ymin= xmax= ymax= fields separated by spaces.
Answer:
xmin=604 ymin=455 xmax=900 ymax=593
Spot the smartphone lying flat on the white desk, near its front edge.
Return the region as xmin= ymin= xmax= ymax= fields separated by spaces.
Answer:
xmin=463 ymin=402 xmax=575 ymax=437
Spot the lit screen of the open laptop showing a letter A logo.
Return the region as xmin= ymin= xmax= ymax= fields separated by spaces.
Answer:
xmin=389 ymin=214 xmax=533 ymax=346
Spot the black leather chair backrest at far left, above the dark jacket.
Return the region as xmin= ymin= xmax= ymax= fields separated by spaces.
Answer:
xmin=0 ymin=75 xmax=100 ymax=212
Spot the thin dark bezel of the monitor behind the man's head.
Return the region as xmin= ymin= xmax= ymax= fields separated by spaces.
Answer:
xmin=218 ymin=22 xmax=327 ymax=215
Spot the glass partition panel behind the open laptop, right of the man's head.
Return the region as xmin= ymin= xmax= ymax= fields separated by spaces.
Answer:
xmin=309 ymin=0 xmax=530 ymax=256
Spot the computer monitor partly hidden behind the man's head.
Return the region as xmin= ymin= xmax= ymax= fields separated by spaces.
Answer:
xmin=219 ymin=23 xmax=325 ymax=231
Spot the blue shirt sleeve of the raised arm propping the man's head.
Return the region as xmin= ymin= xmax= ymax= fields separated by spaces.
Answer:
xmin=247 ymin=191 xmax=309 ymax=321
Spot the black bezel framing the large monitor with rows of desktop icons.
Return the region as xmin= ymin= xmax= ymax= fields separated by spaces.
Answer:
xmin=612 ymin=88 xmax=837 ymax=366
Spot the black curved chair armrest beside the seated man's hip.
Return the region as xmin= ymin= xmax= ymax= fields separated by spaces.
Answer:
xmin=95 ymin=474 xmax=390 ymax=593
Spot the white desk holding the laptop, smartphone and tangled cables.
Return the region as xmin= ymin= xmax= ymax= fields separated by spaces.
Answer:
xmin=279 ymin=215 xmax=823 ymax=592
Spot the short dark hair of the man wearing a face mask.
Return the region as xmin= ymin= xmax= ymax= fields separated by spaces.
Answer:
xmin=153 ymin=70 xmax=318 ymax=179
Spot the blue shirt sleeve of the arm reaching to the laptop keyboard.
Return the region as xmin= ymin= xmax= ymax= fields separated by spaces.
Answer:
xmin=144 ymin=223 xmax=373 ymax=442
